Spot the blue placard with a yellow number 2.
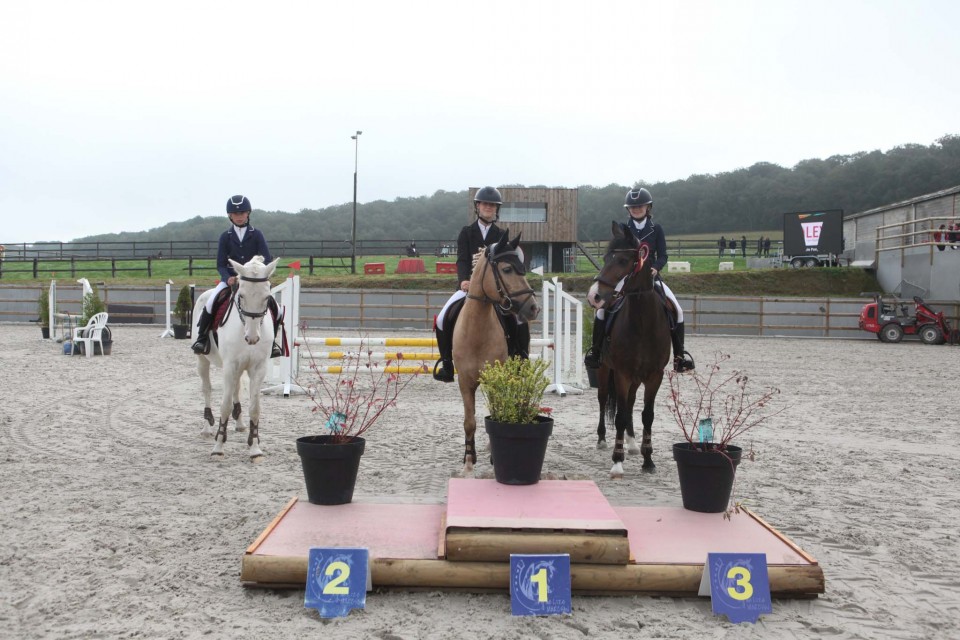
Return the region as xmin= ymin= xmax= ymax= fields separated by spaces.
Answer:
xmin=303 ymin=547 xmax=369 ymax=618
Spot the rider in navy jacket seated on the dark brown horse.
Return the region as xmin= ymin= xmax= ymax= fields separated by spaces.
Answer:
xmin=583 ymin=188 xmax=696 ymax=372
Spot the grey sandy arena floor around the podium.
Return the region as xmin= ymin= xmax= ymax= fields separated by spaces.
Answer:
xmin=0 ymin=325 xmax=960 ymax=639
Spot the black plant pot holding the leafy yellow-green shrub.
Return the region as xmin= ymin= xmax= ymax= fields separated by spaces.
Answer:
xmin=483 ymin=416 xmax=553 ymax=484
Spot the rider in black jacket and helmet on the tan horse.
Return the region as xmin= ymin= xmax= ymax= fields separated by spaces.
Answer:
xmin=433 ymin=187 xmax=530 ymax=382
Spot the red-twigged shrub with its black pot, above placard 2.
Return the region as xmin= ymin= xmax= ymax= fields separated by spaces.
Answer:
xmin=297 ymin=344 xmax=418 ymax=505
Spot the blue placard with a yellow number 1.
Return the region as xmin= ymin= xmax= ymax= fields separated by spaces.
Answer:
xmin=510 ymin=553 xmax=570 ymax=616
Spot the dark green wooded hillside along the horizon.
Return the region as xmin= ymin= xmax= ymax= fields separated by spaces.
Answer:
xmin=76 ymin=134 xmax=960 ymax=242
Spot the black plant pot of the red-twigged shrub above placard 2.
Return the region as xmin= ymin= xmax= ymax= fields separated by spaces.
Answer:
xmin=297 ymin=436 xmax=366 ymax=505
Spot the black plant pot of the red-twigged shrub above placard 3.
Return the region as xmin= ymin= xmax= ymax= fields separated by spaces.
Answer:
xmin=673 ymin=442 xmax=743 ymax=513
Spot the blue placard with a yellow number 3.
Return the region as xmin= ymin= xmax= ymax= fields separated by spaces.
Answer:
xmin=704 ymin=553 xmax=773 ymax=623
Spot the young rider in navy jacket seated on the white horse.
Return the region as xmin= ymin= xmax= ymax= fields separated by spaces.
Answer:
xmin=192 ymin=196 xmax=283 ymax=358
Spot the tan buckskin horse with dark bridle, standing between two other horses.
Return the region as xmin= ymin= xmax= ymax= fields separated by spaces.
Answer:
xmin=453 ymin=229 xmax=540 ymax=476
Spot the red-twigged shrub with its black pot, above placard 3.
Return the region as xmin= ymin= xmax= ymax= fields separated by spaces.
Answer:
xmin=667 ymin=353 xmax=784 ymax=515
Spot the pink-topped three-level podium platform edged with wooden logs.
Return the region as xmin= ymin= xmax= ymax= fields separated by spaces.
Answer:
xmin=240 ymin=479 xmax=824 ymax=598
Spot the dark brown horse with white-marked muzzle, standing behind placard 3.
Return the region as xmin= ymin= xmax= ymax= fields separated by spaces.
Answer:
xmin=587 ymin=222 xmax=670 ymax=478
